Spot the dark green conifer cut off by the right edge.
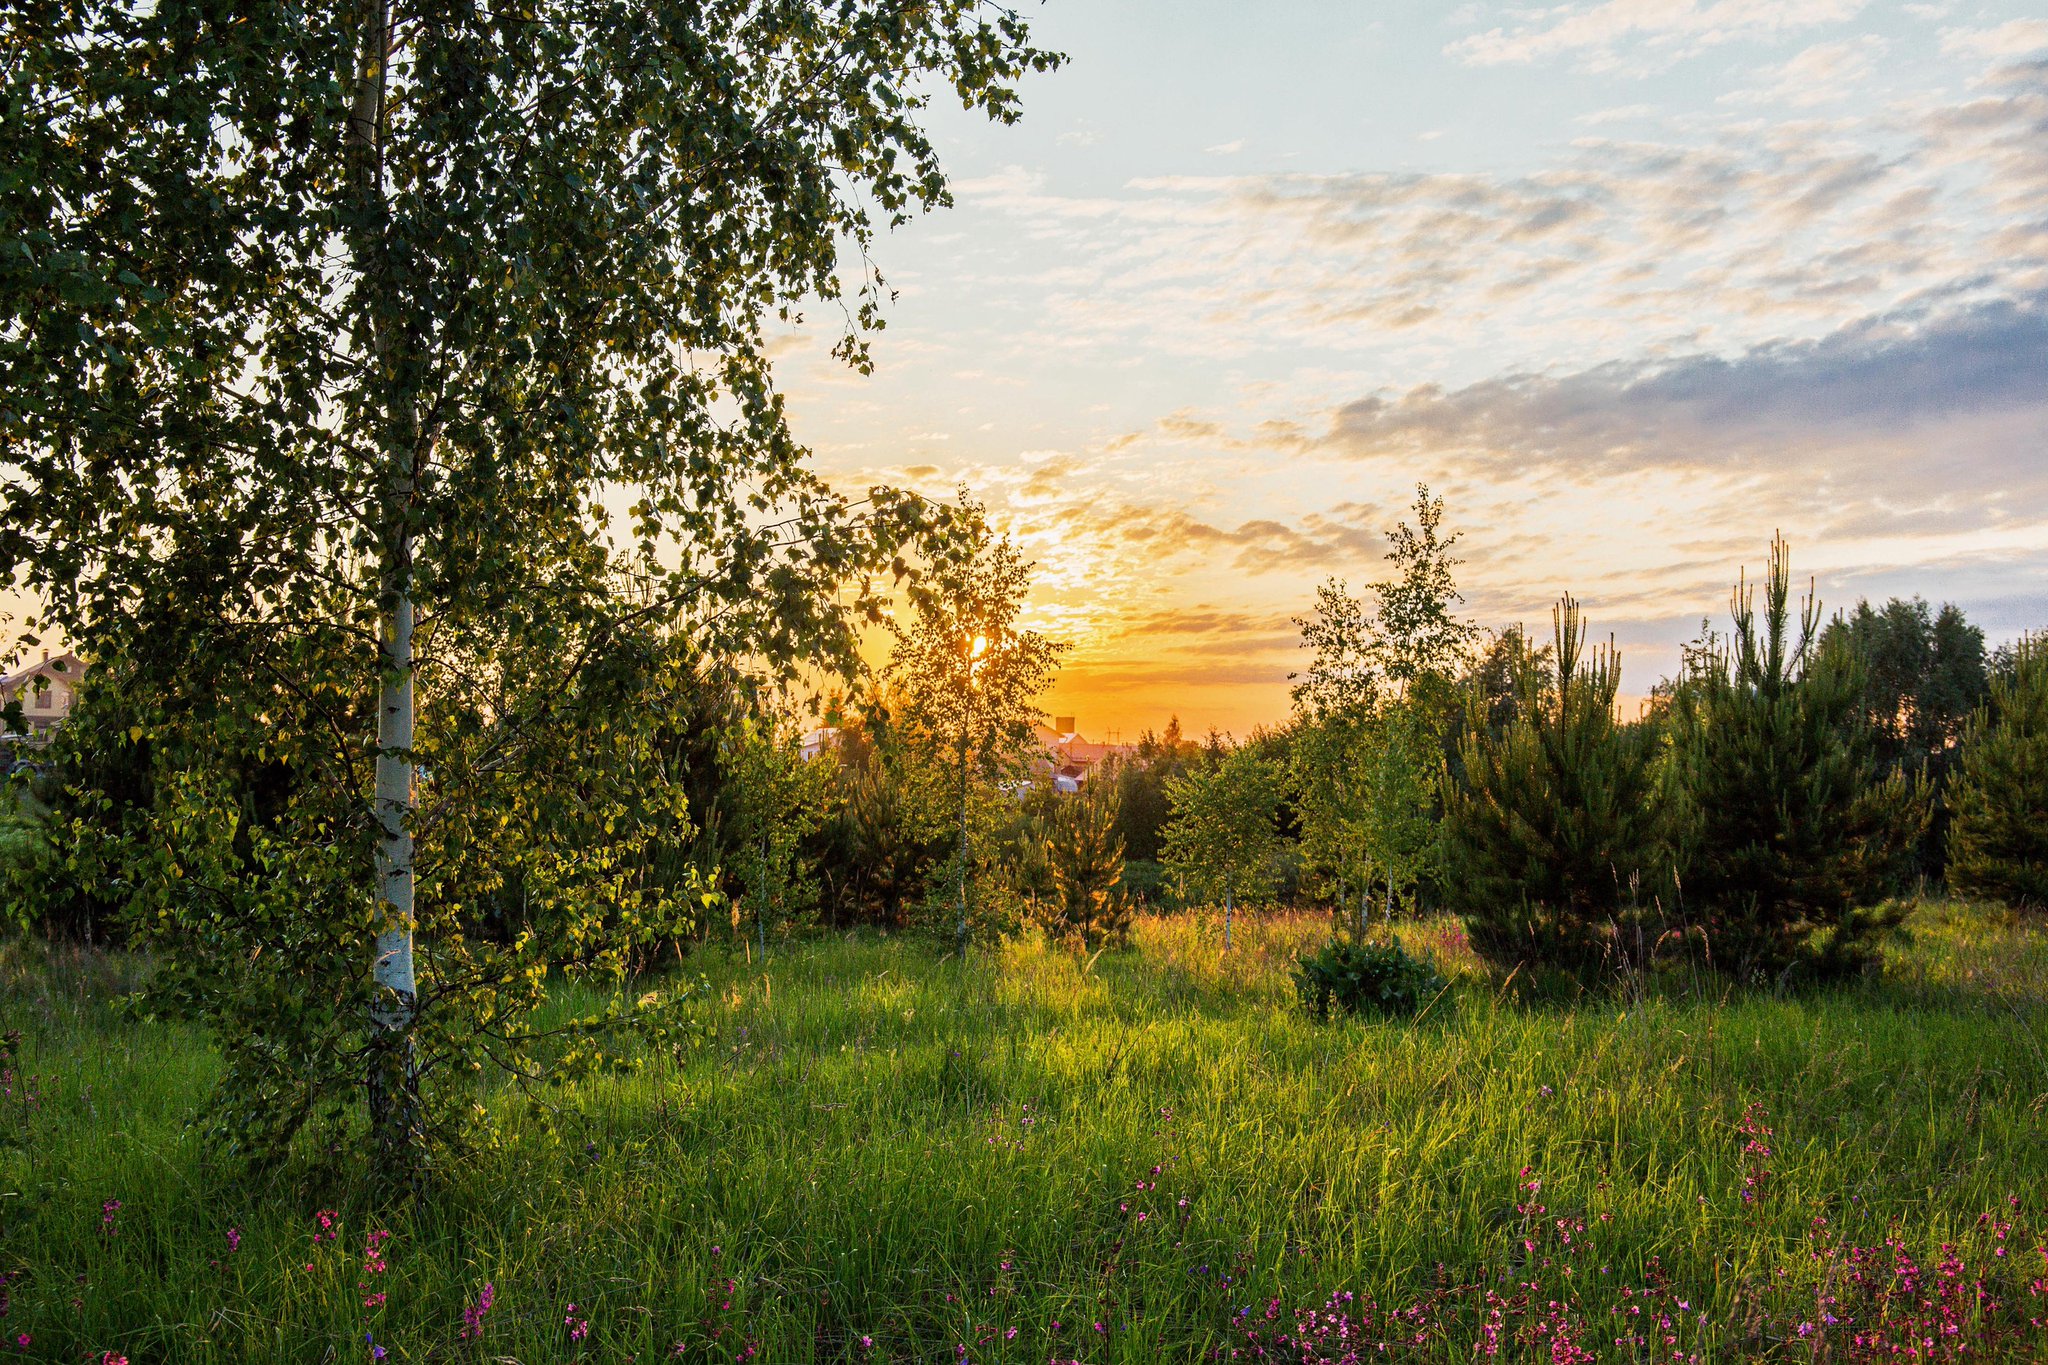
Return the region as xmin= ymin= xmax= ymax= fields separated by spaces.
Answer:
xmin=1948 ymin=636 xmax=2048 ymax=915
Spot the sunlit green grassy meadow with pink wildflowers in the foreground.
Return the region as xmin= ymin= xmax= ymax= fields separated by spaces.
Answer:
xmin=0 ymin=902 xmax=2048 ymax=1365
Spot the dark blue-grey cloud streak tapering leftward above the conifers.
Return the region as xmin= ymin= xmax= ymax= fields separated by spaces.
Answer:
xmin=1329 ymin=293 xmax=2048 ymax=493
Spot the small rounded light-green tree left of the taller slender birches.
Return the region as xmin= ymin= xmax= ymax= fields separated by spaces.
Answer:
xmin=1165 ymin=745 xmax=1284 ymax=929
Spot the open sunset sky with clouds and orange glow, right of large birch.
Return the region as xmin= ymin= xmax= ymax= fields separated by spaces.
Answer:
xmin=782 ymin=0 xmax=2048 ymax=739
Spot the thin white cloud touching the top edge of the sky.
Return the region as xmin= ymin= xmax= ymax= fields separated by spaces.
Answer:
xmin=1444 ymin=0 xmax=1864 ymax=74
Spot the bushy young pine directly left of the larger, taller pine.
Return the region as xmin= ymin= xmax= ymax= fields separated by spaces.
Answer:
xmin=1444 ymin=596 xmax=1665 ymax=974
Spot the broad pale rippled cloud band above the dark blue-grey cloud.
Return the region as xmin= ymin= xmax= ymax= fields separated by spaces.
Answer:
xmin=958 ymin=52 xmax=2048 ymax=386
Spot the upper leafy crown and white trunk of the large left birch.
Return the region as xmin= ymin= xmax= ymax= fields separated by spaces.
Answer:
xmin=0 ymin=0 xmax=1057 ymax=1152
